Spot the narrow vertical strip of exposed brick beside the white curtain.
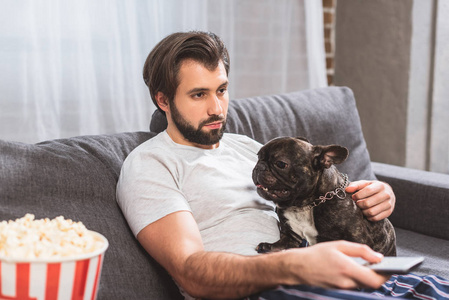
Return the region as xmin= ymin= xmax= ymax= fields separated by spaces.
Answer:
xmin=322 ymin=0 xmax=337 ymax=85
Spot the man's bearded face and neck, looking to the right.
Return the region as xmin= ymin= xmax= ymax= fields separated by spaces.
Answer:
xmin=167 ymin=60 xmax=229 ymax=148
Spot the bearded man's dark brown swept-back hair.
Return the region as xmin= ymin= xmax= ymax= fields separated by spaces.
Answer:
xmin=143 ymin=31 xmax=229 ymax=111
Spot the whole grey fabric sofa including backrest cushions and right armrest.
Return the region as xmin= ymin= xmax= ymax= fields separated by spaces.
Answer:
xmin=0 ymin=87 xmax=449 ymax=300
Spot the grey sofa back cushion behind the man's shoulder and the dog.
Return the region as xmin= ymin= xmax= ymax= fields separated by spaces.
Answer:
xmin=150 ymin=87 xmax=376 ymax=180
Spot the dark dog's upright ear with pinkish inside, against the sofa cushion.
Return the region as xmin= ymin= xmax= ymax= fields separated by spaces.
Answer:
xmin=313 ymin=145 xmax=349 ymax=169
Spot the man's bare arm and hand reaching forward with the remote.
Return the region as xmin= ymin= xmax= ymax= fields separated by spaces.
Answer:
xmin=137 ymin=211 xmax=386 ymax=298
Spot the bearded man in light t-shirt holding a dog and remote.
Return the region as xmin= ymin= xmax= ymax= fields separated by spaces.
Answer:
xmin=117 ymin=32 xmax=440 ymax=299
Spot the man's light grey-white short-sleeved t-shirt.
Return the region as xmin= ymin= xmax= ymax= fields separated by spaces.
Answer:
xmin=117 ymin=131 xmax=279 ymax=255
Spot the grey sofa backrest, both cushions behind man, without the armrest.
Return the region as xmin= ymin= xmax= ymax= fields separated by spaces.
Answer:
xmin=0 ymin=88 xmax=374 ymax=300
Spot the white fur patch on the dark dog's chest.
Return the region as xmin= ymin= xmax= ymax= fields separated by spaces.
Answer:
xmin=284 ymin=207 xmax=318 ymax=245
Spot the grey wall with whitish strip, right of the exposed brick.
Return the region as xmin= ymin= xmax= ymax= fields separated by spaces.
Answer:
xmin=334 ymin=0 xmax=449 ymax=174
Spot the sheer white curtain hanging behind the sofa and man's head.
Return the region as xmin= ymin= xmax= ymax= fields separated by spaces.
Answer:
xmin=0 ymin=0 xmax=326 ymax=142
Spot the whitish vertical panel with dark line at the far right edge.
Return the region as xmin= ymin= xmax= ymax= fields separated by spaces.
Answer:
xmin=406 ymin=0 xmax=449 ymax=174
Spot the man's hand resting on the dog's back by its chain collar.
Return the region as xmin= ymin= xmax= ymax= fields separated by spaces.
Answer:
xmin=346 ymin=180 xmax=396 ymax=221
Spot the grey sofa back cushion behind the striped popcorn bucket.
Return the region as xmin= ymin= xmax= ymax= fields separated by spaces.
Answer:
xmin=0 ymin=132 xmax=179 ymax=300
